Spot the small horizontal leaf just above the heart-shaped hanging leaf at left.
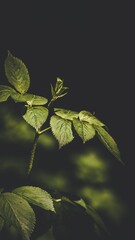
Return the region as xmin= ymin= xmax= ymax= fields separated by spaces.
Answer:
xmin=27 ymin=94 xmax=48 ymax=106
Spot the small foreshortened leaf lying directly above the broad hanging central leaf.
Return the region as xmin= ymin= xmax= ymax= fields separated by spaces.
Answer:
xmin=54 ymin=108 xmax=78 ymax=120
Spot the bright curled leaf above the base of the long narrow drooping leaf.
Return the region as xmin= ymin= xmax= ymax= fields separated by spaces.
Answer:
xmin=79 ymin=111 xmax=105 ymax=126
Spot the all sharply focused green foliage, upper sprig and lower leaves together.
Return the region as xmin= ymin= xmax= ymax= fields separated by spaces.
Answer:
xmin=0 ymin=52 xmax=122 ymax=240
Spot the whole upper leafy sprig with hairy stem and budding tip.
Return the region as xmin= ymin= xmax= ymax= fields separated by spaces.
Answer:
xmin=0 ymin=52 xmax=120 ymax=172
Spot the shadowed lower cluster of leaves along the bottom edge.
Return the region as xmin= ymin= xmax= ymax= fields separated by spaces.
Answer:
xmin=0 ymin=186 xmax=109 ymax=240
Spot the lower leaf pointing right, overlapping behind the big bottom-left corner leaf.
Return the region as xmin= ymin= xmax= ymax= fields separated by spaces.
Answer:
xmin=13 ymin=186 xmax=55 ymax=212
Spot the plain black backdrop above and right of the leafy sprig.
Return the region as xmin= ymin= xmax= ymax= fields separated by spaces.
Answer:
xmin=0 ymin=1 xmax=134 ymax=239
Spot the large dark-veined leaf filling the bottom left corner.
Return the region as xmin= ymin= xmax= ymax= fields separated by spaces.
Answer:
xmin=0 ymin=192 xmax=36 ymax=240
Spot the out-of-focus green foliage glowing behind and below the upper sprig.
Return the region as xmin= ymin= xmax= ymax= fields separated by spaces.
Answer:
xmin=0 ymin=103 xmax=129 ymax=240
